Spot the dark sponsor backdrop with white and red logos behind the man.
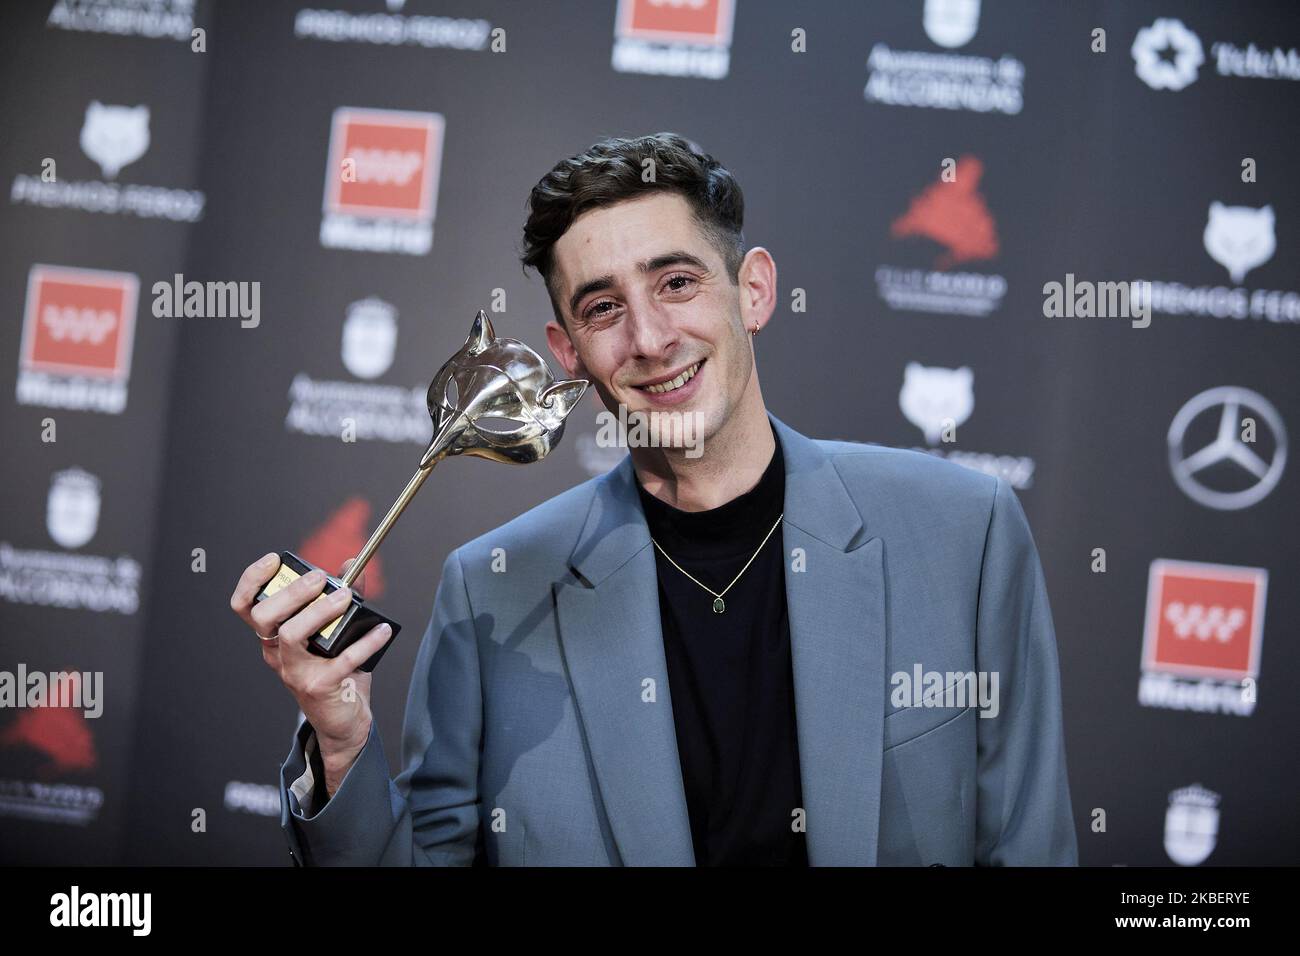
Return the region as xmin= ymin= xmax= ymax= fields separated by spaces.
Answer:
xmin=0 ymin=0 xmax=1300 ymax=866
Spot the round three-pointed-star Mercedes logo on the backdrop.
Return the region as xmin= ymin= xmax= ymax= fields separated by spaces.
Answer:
xmin=1169 ymin=385 xmax=1287 ymax=511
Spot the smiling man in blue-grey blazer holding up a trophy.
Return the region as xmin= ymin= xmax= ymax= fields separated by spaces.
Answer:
xmin=231 ymin=134 xmax=1078 ymax=866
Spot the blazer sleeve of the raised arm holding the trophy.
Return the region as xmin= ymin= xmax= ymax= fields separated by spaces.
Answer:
xmin=280 ymin=551 xmax=482 ymax=866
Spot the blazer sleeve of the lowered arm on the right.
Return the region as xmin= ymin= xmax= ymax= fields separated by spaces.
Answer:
xmin=975 ymin=479 xmax=1079 ymax=866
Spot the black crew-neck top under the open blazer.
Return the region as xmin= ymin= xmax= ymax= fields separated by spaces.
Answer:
xmin=637 ymin=429 xmax=807 ymax=866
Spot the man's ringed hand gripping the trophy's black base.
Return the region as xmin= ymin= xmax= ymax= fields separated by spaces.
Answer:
xmin=230 ymin=553 xmax=391 ymax=795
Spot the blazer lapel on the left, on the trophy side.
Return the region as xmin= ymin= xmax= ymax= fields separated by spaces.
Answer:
xmin=555 ymin=457 xmax=696 ymax=866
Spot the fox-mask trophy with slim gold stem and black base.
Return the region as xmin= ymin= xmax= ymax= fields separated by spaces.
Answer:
xmin=256 ymin=310 xmax=588 ymax=671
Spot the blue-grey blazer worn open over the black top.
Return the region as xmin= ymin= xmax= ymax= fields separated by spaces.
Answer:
xmin=281 ymin=416 xmax=1078 ymax=866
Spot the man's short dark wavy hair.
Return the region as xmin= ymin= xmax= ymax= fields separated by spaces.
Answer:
xmin=520 ymin=133 xmax=745 ymax=325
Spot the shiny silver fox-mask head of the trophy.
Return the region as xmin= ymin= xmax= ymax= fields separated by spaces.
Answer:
xmin=420 ymin=310 xmax=588 ymax=467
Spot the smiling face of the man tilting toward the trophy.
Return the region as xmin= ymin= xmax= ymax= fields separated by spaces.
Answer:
xmin=546 ymin=191 xmax=770 ymax=452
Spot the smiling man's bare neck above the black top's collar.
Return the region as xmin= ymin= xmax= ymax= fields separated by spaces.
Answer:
xmin=631 ymin=390 xmax=776 ymax=511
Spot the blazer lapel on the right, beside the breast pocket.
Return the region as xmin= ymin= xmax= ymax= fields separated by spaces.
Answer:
xmin=770 ymin=415 xmax=885 ymax=866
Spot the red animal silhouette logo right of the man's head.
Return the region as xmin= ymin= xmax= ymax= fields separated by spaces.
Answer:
xmin=891 ymin=156 xmax=997 ymax=269
